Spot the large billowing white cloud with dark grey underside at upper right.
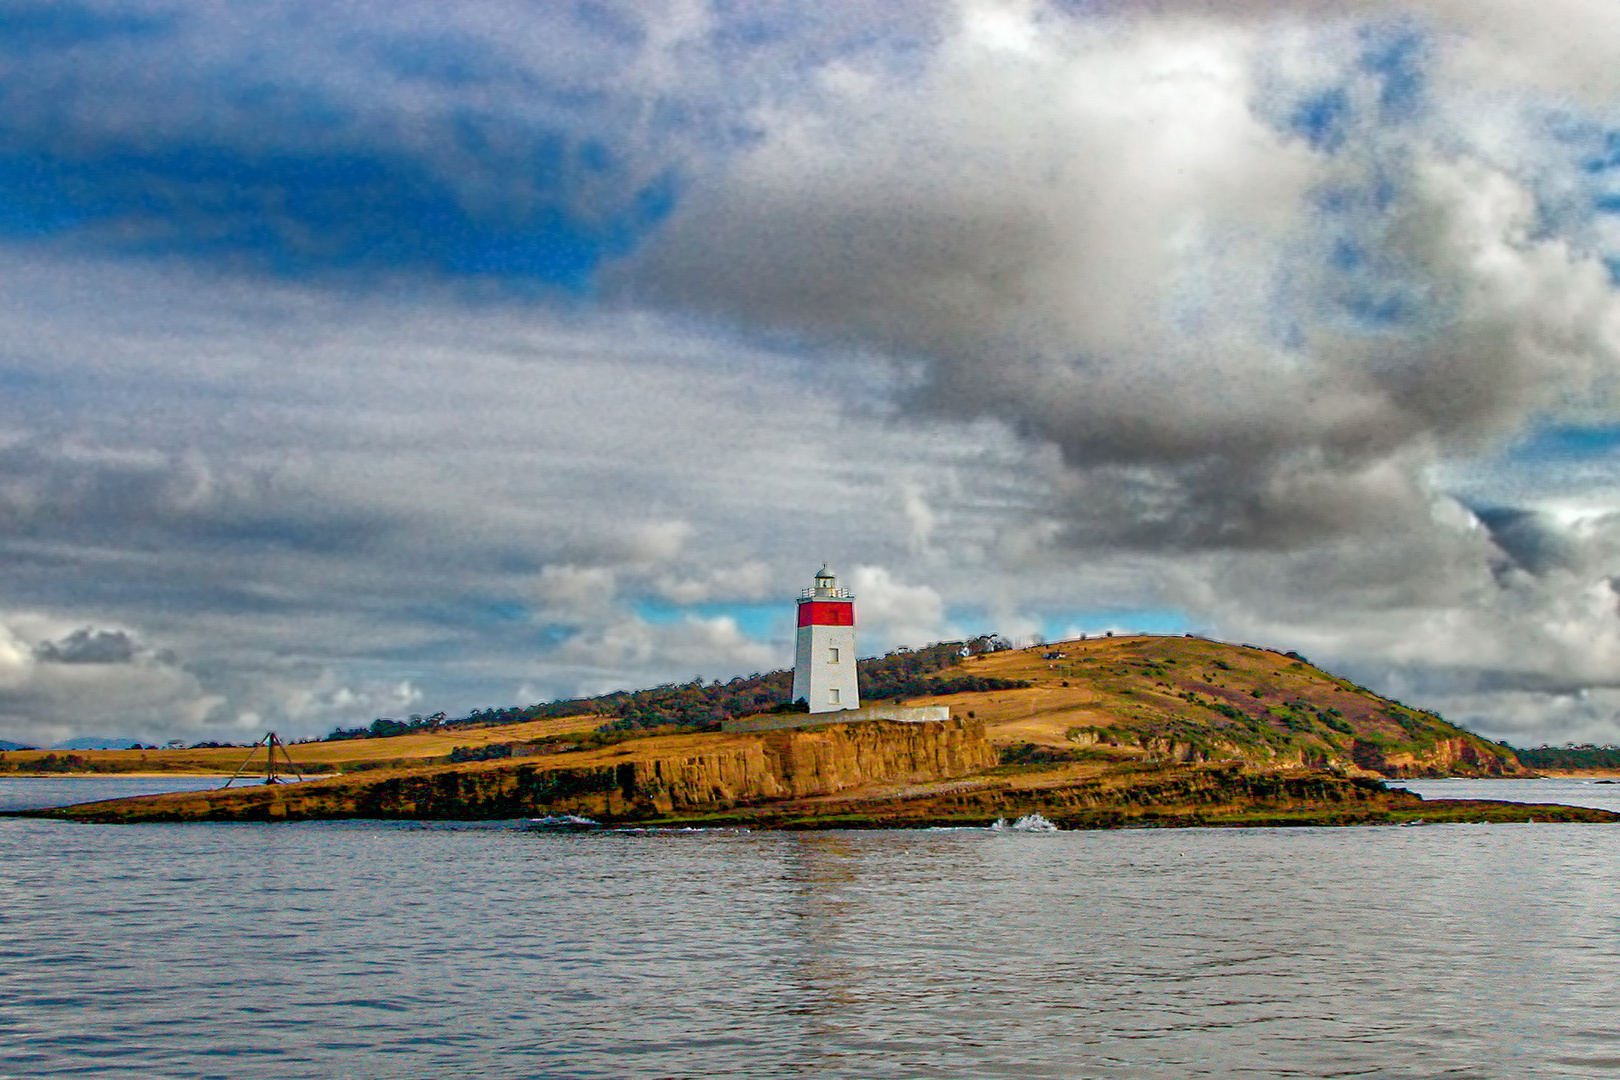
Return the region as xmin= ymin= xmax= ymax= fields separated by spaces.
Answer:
xmin=629 ymin=5 xmax=1617 ymax=549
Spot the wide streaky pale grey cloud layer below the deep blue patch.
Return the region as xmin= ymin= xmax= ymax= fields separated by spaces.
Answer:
xmin=0 ymin=253 xmax=1036 ymax=742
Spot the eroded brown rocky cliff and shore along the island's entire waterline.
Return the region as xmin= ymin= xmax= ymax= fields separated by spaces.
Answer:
xmin=25 ymin=717 xmax=1620 ymax=829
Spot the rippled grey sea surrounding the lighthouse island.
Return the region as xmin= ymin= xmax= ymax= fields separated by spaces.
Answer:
xmin=0 ymin=780 xmax=1620 ymax=1080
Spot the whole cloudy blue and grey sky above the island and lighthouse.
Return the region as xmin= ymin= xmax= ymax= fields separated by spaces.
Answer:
xmin=0 ymin=0 xmax=1620 ymax=746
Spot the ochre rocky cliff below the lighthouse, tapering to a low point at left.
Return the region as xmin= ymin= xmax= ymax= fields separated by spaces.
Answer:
xmin=52 ymin=719 xmax=996 ymax=821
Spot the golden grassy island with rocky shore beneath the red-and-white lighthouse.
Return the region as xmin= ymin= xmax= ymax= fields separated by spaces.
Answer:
xmin=15 ymin=635 xmax=1620 ymax=829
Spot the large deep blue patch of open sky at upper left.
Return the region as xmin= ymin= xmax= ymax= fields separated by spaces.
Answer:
xmin=0 ymin=134 xmax=676 ymax=290
